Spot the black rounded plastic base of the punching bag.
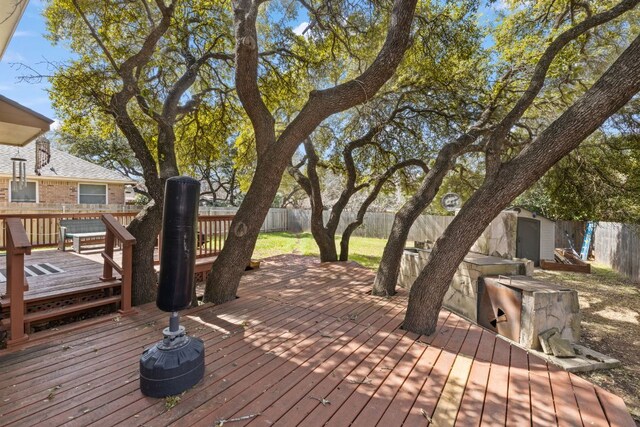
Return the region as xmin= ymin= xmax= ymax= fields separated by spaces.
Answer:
xmin=140 ymin=337 xmax=204 ymax=397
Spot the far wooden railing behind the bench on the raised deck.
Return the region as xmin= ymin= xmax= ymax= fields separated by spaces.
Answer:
xmin=0 ymin=212 xmax=137 ymax=250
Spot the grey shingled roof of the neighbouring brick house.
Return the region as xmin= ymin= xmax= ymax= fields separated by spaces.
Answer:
xmin=0 ymin=142 xmax=135 ymax=184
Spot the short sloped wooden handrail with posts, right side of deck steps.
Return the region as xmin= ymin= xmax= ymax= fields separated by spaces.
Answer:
xmin=100 ymin=214 xmax=136 ymax=314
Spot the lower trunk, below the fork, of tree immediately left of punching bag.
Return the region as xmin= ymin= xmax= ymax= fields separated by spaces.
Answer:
xmin=127 ymin=201 xmax=162 ymax=305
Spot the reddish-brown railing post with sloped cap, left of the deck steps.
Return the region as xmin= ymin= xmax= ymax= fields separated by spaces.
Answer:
xmin=5 ymin=218 xmax=31 ymax=348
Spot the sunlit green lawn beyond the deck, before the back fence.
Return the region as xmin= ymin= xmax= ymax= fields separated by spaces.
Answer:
xmin=253 ymin=232 xmax=387 ymax=269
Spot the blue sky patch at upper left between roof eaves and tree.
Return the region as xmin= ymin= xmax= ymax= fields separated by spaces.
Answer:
xmin=0 ymin=0 xmax=70 ymax=125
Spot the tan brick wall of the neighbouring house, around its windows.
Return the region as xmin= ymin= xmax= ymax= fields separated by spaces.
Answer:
xmin=0 ymin=178 xmax=124 ymax=205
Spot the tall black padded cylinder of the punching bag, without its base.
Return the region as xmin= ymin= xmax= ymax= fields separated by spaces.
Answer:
xmin=156 ymin=176 xmax=200 ymax=312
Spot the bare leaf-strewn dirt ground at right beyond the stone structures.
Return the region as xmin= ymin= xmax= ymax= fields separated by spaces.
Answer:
xmin=534 ymin=264 xmax=640 ymax=424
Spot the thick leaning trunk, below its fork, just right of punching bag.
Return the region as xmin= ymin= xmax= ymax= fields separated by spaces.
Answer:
xmin=204 ymin=150 xmax=289 ymax=304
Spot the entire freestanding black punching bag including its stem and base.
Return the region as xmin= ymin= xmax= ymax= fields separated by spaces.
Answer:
xmin=140 ymin=176 xmax=204 ymax=397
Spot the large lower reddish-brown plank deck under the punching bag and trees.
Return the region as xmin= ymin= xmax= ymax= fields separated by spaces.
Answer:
xmin=0 ymin=256 xmax=634 ymax=426
